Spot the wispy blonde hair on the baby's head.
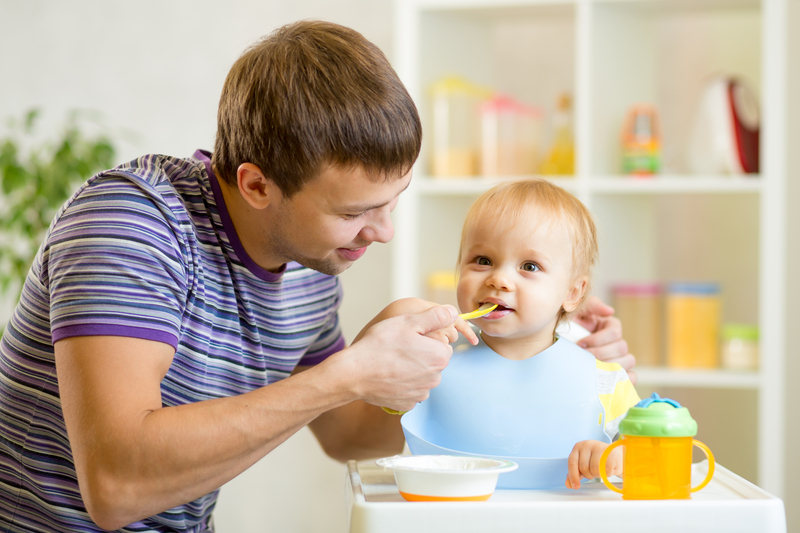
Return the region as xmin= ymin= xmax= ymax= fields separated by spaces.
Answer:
xmin=456 ymin=178 xmax=599 ymax=323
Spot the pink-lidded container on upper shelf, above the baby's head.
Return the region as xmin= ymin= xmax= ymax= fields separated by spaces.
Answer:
xmin=480 ymin=95 xmax=542 ymax=176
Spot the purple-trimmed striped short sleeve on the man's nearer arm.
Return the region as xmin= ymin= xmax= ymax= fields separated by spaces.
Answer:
xmin=45 ymin=174 xmax=187 ymax=347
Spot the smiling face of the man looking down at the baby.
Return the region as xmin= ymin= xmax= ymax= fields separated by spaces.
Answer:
xmin=266 ymin=167 xmax=411 ymax=275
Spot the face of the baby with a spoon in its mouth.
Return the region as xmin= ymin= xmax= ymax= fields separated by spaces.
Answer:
xmin=458 ymin=211 xmax=581 ymax=359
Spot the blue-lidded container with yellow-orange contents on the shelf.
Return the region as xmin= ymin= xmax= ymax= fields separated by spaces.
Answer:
xmin=665 ymin=282 xmax=722 ymax=368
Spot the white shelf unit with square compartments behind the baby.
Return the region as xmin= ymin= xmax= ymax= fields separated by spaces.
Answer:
xmin=392 ymin=0 xmax=788 ymax=495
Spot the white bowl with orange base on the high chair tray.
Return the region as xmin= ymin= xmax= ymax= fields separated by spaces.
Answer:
xmin=376 ymin=455 xmax=517 ymax=502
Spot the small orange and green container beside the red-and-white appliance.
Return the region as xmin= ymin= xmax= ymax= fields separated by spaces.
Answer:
xmin=622 ymin=104 xmax=661 ymax=176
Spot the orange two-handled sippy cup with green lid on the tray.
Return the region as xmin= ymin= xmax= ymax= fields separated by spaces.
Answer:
xmin=600 ymin=393 xmax=714 ymax=500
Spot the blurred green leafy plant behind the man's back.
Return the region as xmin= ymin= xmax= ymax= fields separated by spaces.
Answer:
xmin=0 ymin=109 xmax=114 ymax=295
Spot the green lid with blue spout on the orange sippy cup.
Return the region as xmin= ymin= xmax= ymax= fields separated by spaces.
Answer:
xmin=619 ymin=392 xmax=697 ymax=437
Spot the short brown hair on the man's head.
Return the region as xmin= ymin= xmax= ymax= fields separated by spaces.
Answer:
xmin=212 ymin=21 xmax=422 ymax=197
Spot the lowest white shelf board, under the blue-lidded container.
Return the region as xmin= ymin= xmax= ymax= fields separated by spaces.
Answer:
xmin=635 ymin=367 xmax=761 ymax=390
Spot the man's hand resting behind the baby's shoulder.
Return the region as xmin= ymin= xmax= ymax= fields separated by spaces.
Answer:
xmin=572 ymin=296 xmax=636 ymax=385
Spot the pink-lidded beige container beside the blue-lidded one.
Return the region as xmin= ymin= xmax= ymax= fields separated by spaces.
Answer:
xmin=612 ymin=283 xmax=663 ymax=366
